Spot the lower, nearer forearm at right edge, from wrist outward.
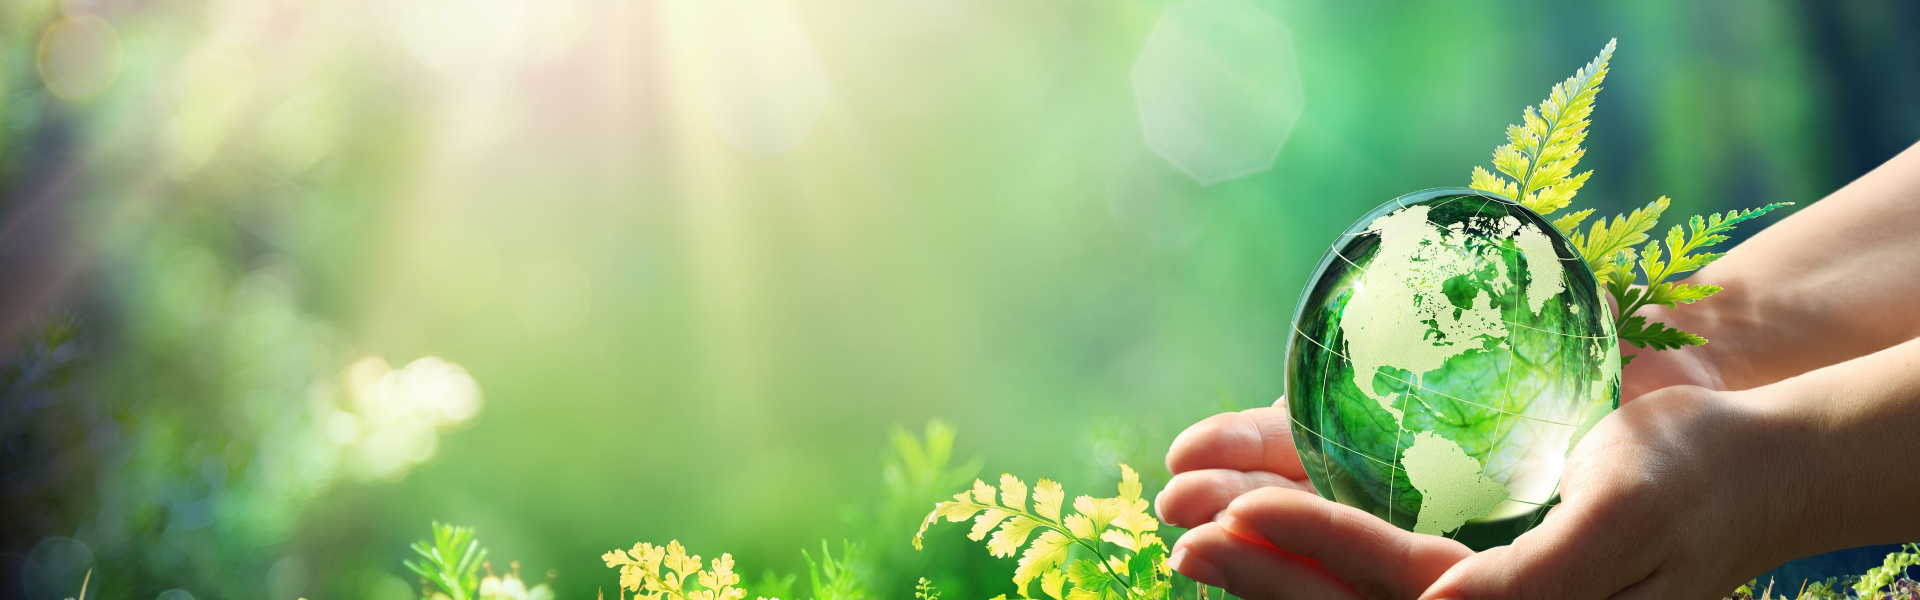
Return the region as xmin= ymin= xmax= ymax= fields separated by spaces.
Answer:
xmin=1743 ymin=338 xmax=1920 ymax=554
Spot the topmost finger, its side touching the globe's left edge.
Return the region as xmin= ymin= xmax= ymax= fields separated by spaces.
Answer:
xmin=1167 ymin=408 xmax=1308 ymax=479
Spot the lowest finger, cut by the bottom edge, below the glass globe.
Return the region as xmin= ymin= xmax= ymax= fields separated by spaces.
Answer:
xmin=1167 ymin=523 xmax=1361 ymax=600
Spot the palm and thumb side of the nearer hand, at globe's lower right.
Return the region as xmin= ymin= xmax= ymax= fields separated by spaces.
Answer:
xmin=1421 ymin=387 xmax=1807 ymax=600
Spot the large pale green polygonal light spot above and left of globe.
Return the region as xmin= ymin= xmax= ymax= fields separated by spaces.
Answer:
xmin=1133 ymin=0 xmax=1306 ymax=185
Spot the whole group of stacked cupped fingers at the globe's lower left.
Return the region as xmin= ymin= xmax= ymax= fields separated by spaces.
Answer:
xmin=1154 ymin=398 xmax=1473 ymax=600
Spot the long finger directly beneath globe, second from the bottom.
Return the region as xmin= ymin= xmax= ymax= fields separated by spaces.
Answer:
xmin=1215 ymin=488 xmax=1473 ymax=598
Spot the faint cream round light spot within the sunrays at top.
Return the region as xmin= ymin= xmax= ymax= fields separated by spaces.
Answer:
xmin=701 ymin=23 xmax=828 ymax=156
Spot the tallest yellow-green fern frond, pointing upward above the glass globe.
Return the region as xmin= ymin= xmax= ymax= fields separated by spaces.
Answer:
xmin=1473 ymin=40 xmax=1617 ymax=215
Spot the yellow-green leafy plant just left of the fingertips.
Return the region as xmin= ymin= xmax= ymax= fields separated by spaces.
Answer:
xmin=914 ymin=463 xmax=1173 ymax=600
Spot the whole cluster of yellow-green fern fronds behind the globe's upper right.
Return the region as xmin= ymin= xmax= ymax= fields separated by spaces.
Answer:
xmin=1471 ymin=40 xmax=1791 ymax=362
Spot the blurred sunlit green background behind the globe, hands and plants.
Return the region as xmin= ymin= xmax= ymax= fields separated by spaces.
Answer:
xmin=0 ymin=0 xmax=1920 ymax=600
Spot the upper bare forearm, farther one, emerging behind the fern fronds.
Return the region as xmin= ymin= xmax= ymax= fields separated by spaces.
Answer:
xmin=1670 ymin=146 xmax=1920 ymax=388
